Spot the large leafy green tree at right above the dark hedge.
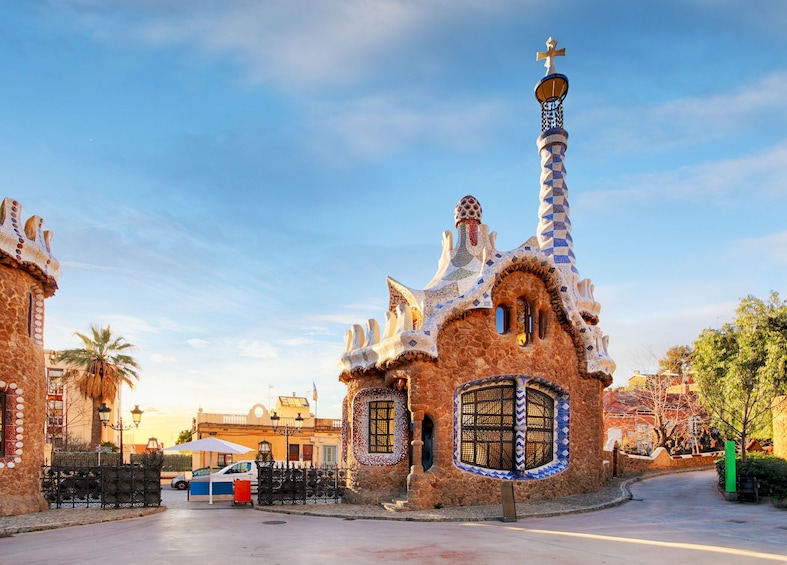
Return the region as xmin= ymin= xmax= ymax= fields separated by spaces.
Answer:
xmin=692 ymin=292 xmax=787 ymax=461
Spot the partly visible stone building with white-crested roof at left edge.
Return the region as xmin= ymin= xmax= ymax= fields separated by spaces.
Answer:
xmin=0 ymin=198 xmax=60 ymax=516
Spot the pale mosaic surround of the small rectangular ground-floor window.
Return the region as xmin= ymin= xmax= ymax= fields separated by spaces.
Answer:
xmin=352 ymin=388 xmax=408 ymax=466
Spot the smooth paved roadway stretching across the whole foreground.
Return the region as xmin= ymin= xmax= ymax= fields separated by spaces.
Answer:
xmin=0 ymin=470 xmax=787 ymax=565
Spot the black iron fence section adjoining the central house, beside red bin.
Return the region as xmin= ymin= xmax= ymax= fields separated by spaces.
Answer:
xmin=257 ymin=461 xmax=347 ymax=505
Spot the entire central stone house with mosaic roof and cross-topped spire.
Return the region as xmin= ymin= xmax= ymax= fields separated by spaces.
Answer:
xmin=340 ymin=38 xmax=615 ymax=509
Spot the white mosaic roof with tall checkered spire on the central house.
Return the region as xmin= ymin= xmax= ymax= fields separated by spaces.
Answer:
xmin=340 ymin=38 xmax=615 ymax=382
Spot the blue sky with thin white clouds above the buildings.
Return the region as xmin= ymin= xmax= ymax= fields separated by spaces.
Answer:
xmin=0 ymin=0 xmax=787 ymax=445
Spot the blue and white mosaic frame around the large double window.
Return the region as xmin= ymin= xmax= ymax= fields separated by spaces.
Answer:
xmin=454 ymin=375 xmax=571 ymax=481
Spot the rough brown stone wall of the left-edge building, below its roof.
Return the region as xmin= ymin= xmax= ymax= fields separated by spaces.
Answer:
xmin=0 ymin=264 xmax=47 ymax=516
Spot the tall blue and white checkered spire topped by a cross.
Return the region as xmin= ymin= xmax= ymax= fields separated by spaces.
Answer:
xmin=535 ymin=37 xmax=579 ymax=275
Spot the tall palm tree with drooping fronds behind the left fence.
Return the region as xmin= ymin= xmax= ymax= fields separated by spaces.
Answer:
xmin=57 ymin=325 xmax=139 ymax=448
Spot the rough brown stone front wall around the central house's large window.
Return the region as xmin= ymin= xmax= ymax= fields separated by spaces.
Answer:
xmin=404 ymin=271 xmax=604 ymax=509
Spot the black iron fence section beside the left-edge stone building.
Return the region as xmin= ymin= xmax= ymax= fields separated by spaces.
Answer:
xmin=41 ymin=453 xmax=163 ymax=508
